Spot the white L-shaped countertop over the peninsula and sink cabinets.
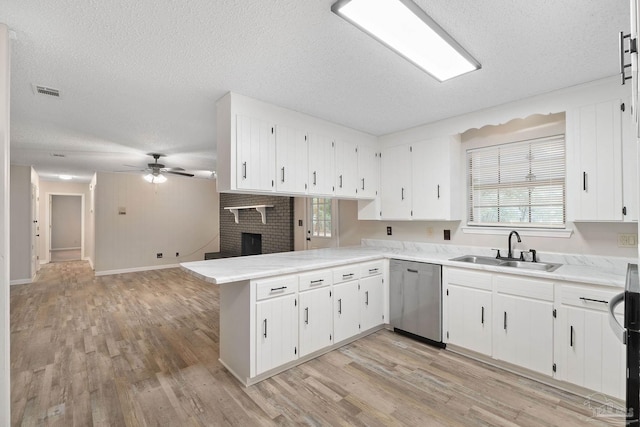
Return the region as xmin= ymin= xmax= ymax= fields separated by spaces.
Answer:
xmin=180 ymin=246 xmax=626 ymax=288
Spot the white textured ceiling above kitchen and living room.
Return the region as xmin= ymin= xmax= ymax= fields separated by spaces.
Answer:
xmin=0 ymin=0 xmax=629 ymax=180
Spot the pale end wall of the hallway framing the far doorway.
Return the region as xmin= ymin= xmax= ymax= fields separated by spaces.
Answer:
xmin=38 ymin=180 xmax=94 ymax=265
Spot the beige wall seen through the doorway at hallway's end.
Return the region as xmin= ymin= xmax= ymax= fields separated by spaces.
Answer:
xmin=51 ymin=195 xmax=82 ymax=250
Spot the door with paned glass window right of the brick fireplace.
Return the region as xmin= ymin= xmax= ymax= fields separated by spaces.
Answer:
xmin=305 ymin=197 xmax=340 ymax=249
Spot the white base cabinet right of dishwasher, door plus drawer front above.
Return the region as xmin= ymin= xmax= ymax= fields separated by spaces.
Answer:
xmin=445 ymin=269 xmax=492 ymax=356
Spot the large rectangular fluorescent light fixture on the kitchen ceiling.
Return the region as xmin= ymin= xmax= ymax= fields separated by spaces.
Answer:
xmin=331 ymin=0 xmax=481 ymax=82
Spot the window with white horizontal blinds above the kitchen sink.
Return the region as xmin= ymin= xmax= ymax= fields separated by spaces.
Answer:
xmin=467 ymin=135 xmax=566 ymax=228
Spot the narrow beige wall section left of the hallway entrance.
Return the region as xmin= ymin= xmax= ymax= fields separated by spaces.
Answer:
xmin=10 ymin=165 xmax=31 ymax=283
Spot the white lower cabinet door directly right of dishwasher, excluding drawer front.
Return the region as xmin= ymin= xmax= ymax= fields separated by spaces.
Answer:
xmin=445 ymin=285 xmax=493 ymax=356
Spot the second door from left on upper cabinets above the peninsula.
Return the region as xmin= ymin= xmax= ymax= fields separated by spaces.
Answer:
xmin=276 ymin=125 xmax=308 ymax=194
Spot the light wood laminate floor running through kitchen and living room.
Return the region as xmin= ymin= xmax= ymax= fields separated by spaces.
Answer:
xmin=11 ymin=261 xmax=623 ymax=426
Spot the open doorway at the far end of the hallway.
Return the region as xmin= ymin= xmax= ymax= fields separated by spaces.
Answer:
xmin=49 ymin=194 xmax=84 ymax=262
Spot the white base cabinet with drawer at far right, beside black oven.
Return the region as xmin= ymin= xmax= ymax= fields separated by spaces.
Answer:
xmin=556 ymin=285 xmax=626 ymax=399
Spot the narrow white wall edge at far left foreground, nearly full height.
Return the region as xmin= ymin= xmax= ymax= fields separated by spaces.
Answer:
xmin=0 ymin=23 xmax=11 ymax=426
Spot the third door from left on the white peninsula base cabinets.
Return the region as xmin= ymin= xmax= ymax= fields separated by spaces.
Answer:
xmin=333 ymin=280 xmax=360 ymax=343
